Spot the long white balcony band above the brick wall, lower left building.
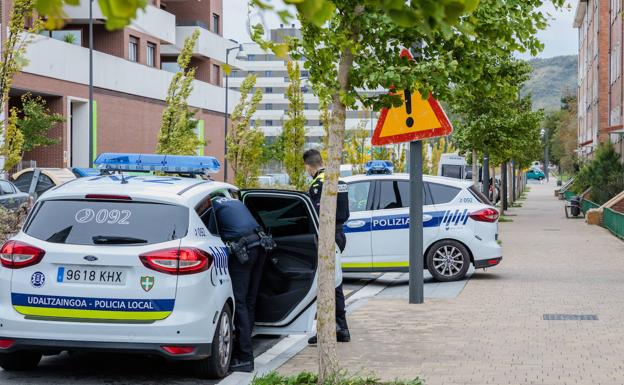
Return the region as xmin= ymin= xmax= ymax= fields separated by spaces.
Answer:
xmin=23 ymin=35 xmax=240 ymax=112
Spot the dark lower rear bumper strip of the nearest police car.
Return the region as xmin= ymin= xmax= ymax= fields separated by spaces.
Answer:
xmin=0 ymin=336 xmax=212 ymax=360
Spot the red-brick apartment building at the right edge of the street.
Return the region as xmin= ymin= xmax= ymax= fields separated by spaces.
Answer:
xmin=574 ymin=0 xmax=624 ymax=157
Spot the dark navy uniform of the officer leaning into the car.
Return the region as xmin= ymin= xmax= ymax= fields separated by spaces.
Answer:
xmin=213 ymin=198 xmax=266 ymax=364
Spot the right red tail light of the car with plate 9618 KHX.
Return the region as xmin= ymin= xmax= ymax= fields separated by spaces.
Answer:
xmin=139 ymin=247 xmax=212 ymax=275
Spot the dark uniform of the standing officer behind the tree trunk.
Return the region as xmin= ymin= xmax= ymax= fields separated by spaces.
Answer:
xmin=309 ymin=168 xmax=349 ymax=339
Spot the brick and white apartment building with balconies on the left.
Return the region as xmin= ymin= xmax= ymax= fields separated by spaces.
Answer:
xmin=7 ymin=0 xmax=238 ymax=179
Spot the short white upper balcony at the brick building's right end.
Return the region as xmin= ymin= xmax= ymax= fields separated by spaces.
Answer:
xmin=160 ymin=26 xmax=238 ymax=68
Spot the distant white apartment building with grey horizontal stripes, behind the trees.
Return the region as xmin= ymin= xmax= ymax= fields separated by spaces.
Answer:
xmin=229 ymin=25 xmax=377 ymax=151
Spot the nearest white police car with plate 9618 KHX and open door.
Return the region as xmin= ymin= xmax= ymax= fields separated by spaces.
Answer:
xmin=0 ymin=154 xmax=342 ymax=377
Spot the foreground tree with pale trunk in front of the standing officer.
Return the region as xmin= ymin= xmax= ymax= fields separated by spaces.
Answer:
xmin=253 ymin=0 xmax=562 ymax=383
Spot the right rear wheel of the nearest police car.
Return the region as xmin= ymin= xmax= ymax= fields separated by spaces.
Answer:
xmin=191 ymin=304 xmax=234 ymax=378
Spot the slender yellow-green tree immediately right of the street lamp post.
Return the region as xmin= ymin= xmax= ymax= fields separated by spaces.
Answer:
xmin=226 ymin=75 xmax=264 ymax=188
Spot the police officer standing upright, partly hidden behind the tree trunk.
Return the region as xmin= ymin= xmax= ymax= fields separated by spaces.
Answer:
xmin=303 ymin=149 xmax=351 ymax=344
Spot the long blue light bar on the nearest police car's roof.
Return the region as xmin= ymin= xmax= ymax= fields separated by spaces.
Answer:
xmin=93 ymin=152 xmax=221 ymax=174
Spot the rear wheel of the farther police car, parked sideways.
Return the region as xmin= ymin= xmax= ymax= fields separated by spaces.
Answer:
xmin=427 ymin=240 xmax=470 ymax=282
